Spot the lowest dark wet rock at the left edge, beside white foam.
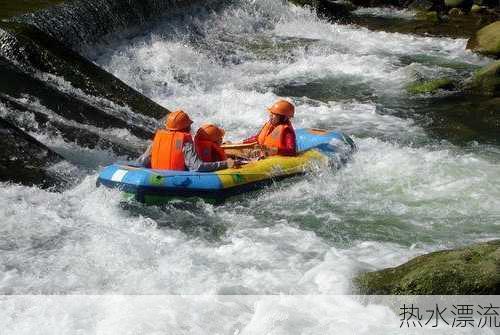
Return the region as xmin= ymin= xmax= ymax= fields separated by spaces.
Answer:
xmin=0 ymin=118 xmax=67 ymax=189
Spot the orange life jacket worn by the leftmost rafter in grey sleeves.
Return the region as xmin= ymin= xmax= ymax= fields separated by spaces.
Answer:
xmin=151 ymin=129 xmax=193 ymax=171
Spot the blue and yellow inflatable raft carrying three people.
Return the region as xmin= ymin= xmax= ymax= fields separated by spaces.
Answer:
xmin=98 ymin=129 xmax=356 ymax=204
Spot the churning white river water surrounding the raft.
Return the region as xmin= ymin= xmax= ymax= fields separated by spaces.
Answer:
xmin=0 ymin=0 xmax=500 ymax=334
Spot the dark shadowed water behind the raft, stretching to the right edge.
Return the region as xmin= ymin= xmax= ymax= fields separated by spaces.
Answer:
xmin=273 ymin=70 xmax=500 ymax=146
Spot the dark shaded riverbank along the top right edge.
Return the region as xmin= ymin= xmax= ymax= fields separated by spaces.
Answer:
xmin=291 ymin=0 xmax=500 ymax=38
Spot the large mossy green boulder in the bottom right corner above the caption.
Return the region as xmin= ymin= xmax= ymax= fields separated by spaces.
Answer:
xmin=354 ymin=240 xmax=500 ymax=295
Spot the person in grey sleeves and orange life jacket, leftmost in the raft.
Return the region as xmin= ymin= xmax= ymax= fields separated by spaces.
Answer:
xmin=139 ymin=110 xmax=235 ymax=172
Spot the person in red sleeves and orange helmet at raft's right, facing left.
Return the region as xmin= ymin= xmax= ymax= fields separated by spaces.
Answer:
xmin=243 ymin=100 xmax=297 ymax=156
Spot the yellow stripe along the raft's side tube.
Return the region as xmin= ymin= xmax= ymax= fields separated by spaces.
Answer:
xmin=215 ymin=150 xmax=327 ymax=188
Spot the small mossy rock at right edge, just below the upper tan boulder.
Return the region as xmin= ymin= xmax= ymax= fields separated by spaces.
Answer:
xmin=465 ymin=61 xmax=500 ymax=96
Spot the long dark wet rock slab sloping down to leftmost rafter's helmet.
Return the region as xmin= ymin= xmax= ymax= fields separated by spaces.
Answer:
xmin=0 ymin=22 xmax=168 ymax=123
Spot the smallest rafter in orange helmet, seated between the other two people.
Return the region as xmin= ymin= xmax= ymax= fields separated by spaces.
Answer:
xmin=194 ymin=123 xmax=227 ymax=162
